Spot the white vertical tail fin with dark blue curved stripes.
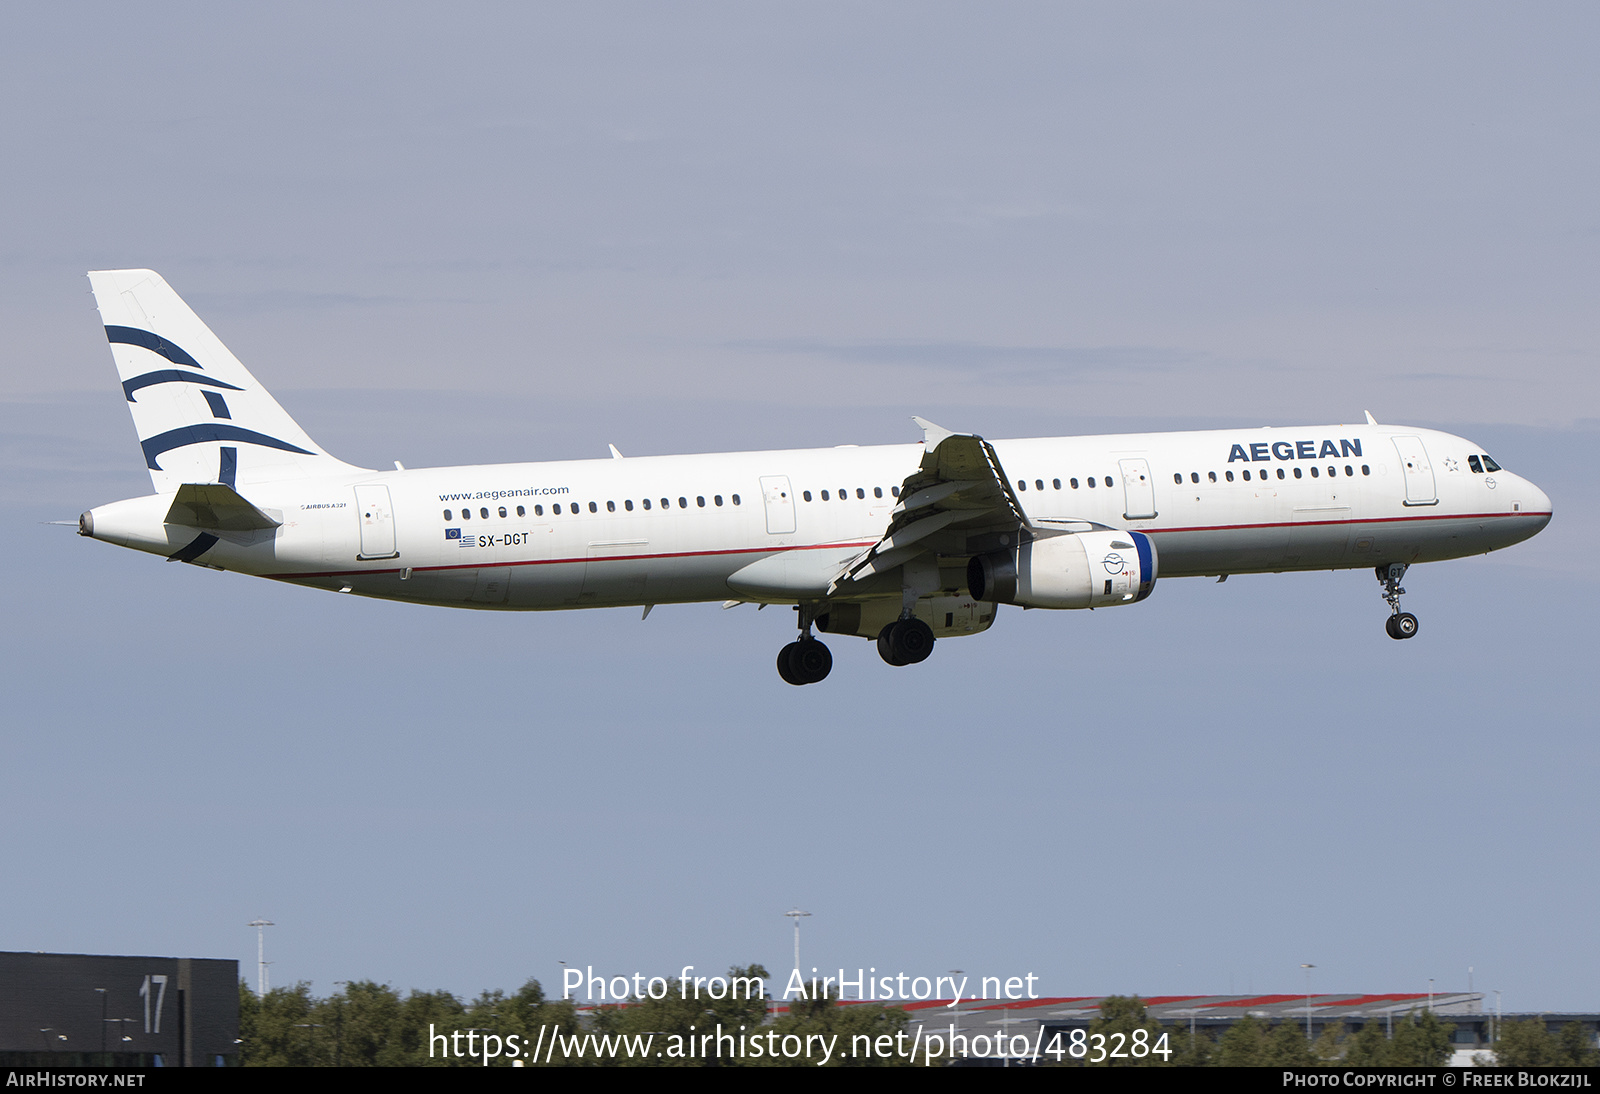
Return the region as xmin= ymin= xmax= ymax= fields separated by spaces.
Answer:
xmin=90 ymin=270 xmax=366 ymax=494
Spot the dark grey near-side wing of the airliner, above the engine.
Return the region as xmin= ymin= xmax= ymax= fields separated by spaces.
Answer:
xmin=827 ymin=417 xmax=1048 ymax=597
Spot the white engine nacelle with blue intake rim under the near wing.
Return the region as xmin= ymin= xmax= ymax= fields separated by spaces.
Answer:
xmin=966 ymin=531 xmax=1157 ymax=608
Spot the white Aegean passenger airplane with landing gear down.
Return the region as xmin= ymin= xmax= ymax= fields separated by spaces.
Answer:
xmin=78 ymin=270 xmax=1552 ymax=685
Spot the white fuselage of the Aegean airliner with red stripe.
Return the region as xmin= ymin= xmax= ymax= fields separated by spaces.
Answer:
xmin=90 ymin=425 xmax=1550 ymax=611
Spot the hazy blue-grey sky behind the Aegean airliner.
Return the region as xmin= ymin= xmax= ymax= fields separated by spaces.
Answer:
xmin=0 ymin=2 xmax=1600 ymax=1011
